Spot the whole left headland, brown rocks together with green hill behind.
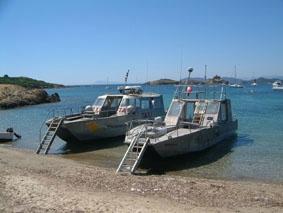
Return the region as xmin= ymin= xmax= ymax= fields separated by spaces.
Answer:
xmin=0 ymin=75 xmax=63 ymax=109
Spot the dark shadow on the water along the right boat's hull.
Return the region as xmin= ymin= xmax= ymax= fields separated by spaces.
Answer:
xmin=141 ymin=135 xmax=253 ymax=175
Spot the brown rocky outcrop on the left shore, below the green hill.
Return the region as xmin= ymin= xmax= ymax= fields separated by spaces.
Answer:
xmin=0 ymin=84 xmax=60 ymax=109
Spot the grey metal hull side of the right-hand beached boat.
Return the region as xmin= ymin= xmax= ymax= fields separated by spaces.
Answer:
xmin=150 ymin=120 xmax=238 ymax=157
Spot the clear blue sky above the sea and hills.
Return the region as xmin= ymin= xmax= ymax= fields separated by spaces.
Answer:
xmin=0 ymin=0 xmax=283 ymax=84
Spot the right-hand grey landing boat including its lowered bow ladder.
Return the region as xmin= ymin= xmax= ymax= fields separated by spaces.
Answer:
xmin=117 ymin=68 xmax=238 ymax=173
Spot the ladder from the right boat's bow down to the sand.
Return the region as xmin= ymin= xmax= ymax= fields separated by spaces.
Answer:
xmin=116 ymin=125 xmax=149 ymax=174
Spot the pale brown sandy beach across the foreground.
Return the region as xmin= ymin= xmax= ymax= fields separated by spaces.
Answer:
xmin=0 ymin=147 xmax=283 ymax=212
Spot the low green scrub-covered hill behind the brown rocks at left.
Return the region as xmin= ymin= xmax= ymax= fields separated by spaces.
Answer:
xmin=0 ymin=75 xmax=64 ymax=89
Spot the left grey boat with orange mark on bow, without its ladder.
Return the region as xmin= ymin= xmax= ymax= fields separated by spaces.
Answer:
xmin=43 ymin=86 xmax=165 ymax=142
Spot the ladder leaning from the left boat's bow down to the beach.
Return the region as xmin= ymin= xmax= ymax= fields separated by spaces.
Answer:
xmin=36 ymin=117 xmax=64 ymax=155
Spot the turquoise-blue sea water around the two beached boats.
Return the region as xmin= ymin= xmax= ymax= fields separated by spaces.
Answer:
xmin=0 ymin=85 xmax=283 ymax=182
